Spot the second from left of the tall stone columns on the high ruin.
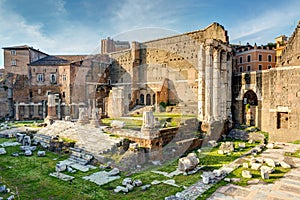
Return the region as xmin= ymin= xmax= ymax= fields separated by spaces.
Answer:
xmin=204 ymin=45 xmax=213 ymax=123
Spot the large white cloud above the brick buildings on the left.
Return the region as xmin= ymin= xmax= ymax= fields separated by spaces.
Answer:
xmin=0 ymin=1 xmax=100 ymax=67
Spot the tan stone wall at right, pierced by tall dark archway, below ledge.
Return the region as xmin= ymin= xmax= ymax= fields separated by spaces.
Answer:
xmin=233 ymin=66 xmax=300 ymax=141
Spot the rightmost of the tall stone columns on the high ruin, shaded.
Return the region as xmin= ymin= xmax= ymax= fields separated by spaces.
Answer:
xmin=220 ymin=51 xmax=227 ymax=120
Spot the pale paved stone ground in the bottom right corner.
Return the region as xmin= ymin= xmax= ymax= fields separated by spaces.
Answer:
xmin=209 ymin=143 xmax=300 ymax=200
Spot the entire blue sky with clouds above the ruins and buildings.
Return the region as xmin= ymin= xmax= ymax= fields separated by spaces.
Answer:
xmin=0 ymin=0 xmax=300 ymax=66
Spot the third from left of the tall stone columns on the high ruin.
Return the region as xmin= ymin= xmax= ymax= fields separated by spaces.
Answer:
xmin=212 ymin=49 xmax=221 ymax=121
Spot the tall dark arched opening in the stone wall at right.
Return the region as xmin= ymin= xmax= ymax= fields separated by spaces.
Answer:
xmin=243 ymin=90 xmax=258 ymax=126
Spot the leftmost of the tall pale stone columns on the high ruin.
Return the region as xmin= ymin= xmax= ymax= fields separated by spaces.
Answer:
xmin=198 ymin=44 xmax=205 ymax=121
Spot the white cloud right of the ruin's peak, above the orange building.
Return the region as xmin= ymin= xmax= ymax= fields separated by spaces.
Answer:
xmin=229 ymin=1 xmax=300 ymax=42
